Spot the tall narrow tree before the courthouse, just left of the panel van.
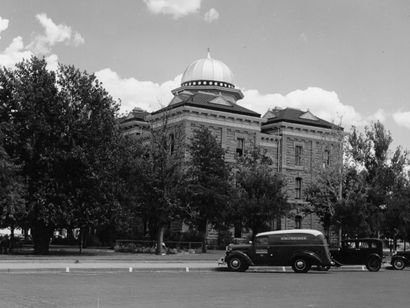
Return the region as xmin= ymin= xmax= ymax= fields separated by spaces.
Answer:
xmin=185 ymin=128 xmax=230 ymax=252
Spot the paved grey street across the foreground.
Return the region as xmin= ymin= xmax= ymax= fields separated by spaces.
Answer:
xmin=0 ymin=269 xmax=410 ymax=308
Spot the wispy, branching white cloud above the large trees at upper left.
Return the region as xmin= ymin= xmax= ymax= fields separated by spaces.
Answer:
xmin=28 ymin=13 xmax=84 ymax=55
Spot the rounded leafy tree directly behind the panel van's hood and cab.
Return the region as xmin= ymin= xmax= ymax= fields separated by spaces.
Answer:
xmin=232 ymin=148 xmax=289 ymax=240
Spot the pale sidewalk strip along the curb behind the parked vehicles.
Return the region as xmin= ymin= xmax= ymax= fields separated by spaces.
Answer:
xmin=0 ymin=249 xmax=389 ymax=275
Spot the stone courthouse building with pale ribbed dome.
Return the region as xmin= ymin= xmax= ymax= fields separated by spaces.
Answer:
xmin=121 ymin=53 xmax=341 ymax=241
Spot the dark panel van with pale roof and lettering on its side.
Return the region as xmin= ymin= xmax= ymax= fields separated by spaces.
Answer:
xmin=221 ymin=229 xmax=332 ymax=273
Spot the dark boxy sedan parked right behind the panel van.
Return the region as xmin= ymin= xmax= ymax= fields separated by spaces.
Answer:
xmin=330 ymin=238 xmax=383 ymax=272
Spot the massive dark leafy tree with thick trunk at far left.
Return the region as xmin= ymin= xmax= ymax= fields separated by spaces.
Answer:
xmin=0 ymin=57 xmax=118 ymax=253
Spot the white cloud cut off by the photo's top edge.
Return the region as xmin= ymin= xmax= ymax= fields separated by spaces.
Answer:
xmin=144 ymin=0 xmax=201 ymax=19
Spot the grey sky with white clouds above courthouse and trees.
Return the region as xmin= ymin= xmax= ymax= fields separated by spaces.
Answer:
xmin=0 ymin=0 xmax=410 ymax=150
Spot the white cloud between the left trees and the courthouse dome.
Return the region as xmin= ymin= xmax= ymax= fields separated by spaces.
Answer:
xmin=95 ymin=68 xmax=181 ymax=112
